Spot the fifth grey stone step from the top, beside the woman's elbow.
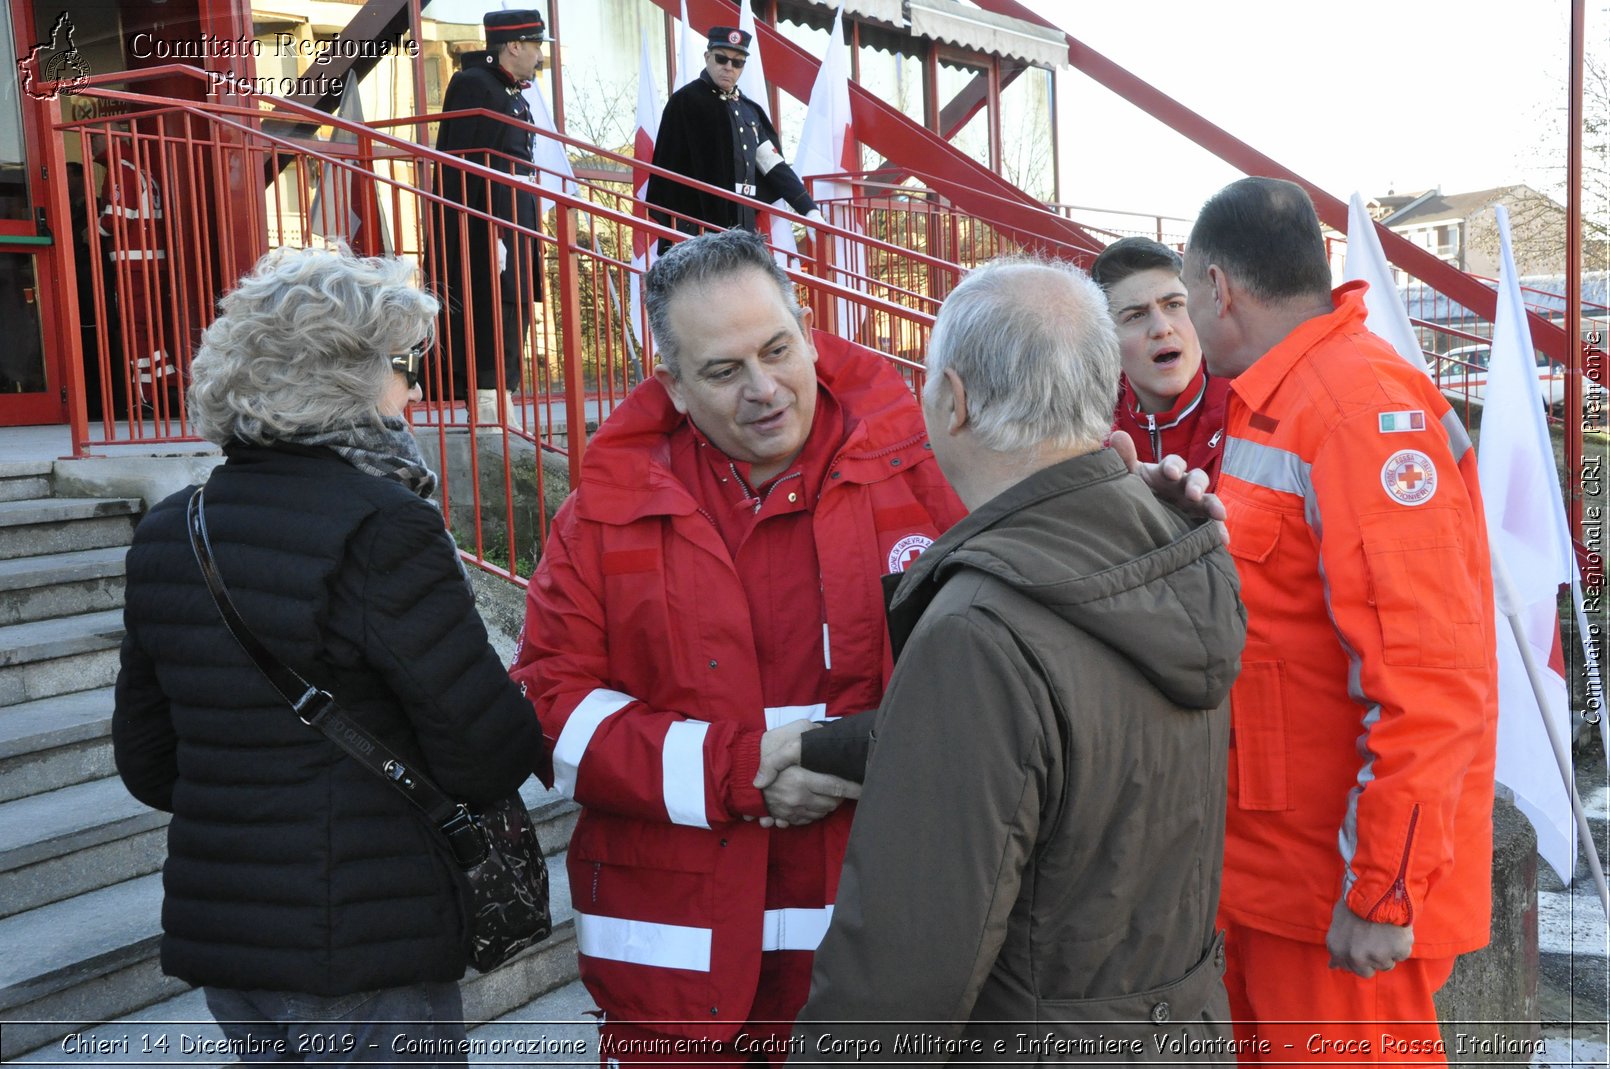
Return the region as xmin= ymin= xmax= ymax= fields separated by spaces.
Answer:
xmin=0 ymin=687 xmax=114 ymax=802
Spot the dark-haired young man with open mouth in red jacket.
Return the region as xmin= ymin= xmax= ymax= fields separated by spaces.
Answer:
xmin=1090 ymin=237 xmax=1230 ymax=488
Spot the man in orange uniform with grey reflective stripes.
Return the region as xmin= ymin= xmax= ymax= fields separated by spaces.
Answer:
xmin=1185 ymin=179 xmax=1497 ymax=1064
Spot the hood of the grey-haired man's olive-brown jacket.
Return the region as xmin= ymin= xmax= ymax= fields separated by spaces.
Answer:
xmin=890 ymin=449 xmax=1246 ymax=708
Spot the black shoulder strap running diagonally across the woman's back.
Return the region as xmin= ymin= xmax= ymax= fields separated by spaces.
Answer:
xmin=185 ymin=488 xmax=486 ymax=868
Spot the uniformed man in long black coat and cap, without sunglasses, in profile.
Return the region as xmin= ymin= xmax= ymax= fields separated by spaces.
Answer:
xmin=436 ymin=11 xmax=547 ymax=427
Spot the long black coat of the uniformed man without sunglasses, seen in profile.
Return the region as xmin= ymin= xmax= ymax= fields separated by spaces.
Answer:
xmin=436 ymin=52 xmax=543 ymax=301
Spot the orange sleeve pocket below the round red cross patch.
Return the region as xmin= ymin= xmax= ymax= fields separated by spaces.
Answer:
xmin=1359 ymin=509 xmax=1491 ymax=668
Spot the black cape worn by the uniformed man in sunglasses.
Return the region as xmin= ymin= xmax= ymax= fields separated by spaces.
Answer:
xmin=646 ymin=72 xmax=816 ymax=232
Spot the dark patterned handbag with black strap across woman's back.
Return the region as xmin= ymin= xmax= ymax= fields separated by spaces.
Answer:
xmin=185 ymin=489 xmax=554 ymax=972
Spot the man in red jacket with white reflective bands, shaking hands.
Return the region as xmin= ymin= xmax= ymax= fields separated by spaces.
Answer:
xmin=512 ymin=230 xmax=964 ymax=1064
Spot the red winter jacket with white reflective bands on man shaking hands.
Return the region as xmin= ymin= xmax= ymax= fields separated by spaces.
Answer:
xmin=512 ymin=333 xmax=964 ymax=1040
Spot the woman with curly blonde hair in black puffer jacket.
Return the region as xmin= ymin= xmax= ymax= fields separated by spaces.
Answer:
xmin=113 ymin=250 xmax=543 ymax=1066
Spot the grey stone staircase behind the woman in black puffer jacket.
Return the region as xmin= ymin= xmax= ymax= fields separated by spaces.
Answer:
xmin=0 ymin=460 xmax=589 ymax=1064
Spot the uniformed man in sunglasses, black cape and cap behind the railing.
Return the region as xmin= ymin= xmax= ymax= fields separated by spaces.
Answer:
xmin=646 ymin=26 xmax=821 ymax=249
